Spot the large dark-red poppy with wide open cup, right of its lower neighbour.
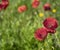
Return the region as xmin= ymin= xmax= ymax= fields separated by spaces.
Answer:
xmin=43 ymin=17 xmax=58 ymax=30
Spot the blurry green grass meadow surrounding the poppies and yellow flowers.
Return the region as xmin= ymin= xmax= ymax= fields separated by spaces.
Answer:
xmin=0 ymin=0 xmax=60 ymax=50
